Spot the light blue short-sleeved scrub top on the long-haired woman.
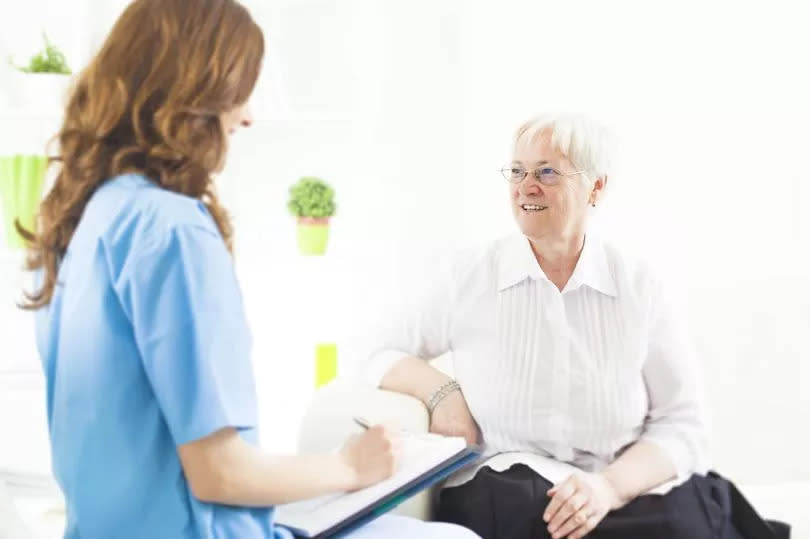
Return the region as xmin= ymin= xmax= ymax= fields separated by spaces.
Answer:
xmin=37 ymin=175 xmax=290 ymax=539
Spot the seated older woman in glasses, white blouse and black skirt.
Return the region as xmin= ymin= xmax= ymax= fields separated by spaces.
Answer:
xmin=366 ymin=116 xmax=788 ymax=539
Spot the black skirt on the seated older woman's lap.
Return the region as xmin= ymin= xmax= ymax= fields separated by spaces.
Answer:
xmin=437 ymin=464 xmax=790 ymax=539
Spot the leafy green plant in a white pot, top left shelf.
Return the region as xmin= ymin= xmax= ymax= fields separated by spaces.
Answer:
xmin=9 ymin=33 xmax=71 ymax=113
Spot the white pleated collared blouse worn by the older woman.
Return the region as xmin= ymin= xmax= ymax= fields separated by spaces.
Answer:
xmin=363 ymin=234 xmax=709 ymax=493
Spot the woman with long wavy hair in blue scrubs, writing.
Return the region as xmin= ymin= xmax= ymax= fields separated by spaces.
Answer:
xmin=21 ymin=0 xmax=473 ymax=539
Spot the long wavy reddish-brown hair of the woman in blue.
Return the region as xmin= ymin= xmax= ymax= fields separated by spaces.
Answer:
xmin=17 ymin=0 xmax=264 ymax=309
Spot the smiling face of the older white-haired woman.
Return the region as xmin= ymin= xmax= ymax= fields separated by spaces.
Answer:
xmin=509 ymin=132 xmax=604 ymax=242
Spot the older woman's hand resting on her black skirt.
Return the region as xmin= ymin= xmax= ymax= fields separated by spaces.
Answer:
xmin=543 ymin=472 xmax=625 ymax=539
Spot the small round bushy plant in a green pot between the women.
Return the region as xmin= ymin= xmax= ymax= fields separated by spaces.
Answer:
xmin=287 ymin=177 xmax=336 ymax=255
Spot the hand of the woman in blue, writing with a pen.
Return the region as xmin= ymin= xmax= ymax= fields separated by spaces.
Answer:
xmin=340 ymin=425 xmax=397 ymax=490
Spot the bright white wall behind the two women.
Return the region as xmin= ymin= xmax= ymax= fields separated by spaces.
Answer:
xmin=0 ymin=0 xmax=810 ymax=488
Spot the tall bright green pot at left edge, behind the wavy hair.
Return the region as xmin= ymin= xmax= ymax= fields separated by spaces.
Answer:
xmin=0 ymin=155 xmax=48 ymax=249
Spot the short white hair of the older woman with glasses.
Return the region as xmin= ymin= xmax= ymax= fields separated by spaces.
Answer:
xmin=514 ymin=114 xmax=613 ymax=183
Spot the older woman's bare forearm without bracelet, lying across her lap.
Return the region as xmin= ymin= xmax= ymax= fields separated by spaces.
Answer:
xmin=602 ymin=441 xmax=677 ymax=503
